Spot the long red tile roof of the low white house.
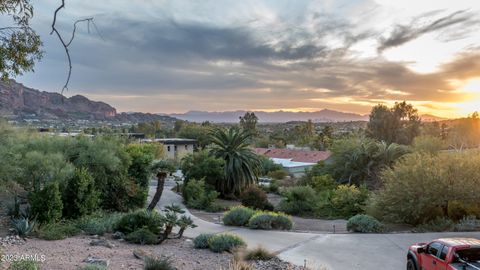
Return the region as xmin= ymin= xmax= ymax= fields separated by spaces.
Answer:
xmin=255 ymin=148 xmax=330 ymax=163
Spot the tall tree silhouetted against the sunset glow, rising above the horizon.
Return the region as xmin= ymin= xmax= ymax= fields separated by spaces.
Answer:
xmin=367 ymin=101 xmax=421 ymax=144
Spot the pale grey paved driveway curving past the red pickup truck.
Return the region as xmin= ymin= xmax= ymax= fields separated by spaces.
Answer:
xmin=150 ymin=181 xmax=480 ymax=270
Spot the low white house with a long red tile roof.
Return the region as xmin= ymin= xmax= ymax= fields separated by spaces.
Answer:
xmin=255 ymin=148 xmax=330 ymax=177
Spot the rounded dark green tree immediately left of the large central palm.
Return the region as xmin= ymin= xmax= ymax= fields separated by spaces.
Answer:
xmin=180 ymin=150 xmax=225 ymax=190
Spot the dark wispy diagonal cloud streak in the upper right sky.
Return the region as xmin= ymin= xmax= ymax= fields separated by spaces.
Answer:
xmin=377 ymin=10 xmax=478 ymax=52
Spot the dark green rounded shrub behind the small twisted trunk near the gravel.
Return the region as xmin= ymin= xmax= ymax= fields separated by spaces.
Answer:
xmin=115 ymin=210 xmax=165 ymax=235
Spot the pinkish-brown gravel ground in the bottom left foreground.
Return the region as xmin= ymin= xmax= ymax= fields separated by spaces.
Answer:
xmin=4 ymin=236 xmax=233 ymax=270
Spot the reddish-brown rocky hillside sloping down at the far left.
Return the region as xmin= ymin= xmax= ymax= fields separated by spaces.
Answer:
xmin=0 ymin=80 xmax=117 ymax=120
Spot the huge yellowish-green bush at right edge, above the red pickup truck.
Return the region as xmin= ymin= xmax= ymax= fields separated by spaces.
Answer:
xmin=367 ymin=151 xmax=480 ymax=225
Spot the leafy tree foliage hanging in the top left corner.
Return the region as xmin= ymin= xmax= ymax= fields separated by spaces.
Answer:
xmin=0 ymin=0 xmax=42 ymax=80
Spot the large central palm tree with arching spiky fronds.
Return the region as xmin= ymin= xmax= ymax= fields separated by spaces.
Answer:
xmin=211 ymin=127 xmax=260 ymax=196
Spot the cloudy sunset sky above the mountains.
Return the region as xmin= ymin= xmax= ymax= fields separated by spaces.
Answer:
xmin=17 ymin=0 xmax=480 ymax=117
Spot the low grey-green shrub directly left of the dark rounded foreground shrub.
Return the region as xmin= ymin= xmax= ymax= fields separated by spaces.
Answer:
xmin=76 ymin=213 xmax=122 ymax=235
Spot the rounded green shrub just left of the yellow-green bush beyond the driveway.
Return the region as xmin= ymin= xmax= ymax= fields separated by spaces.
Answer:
xmin=278 ymin=186 xmax=317 ymax=216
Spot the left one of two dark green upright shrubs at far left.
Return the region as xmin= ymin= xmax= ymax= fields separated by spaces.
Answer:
xmin=29 ymin=182 xmax=63 ymax=223
